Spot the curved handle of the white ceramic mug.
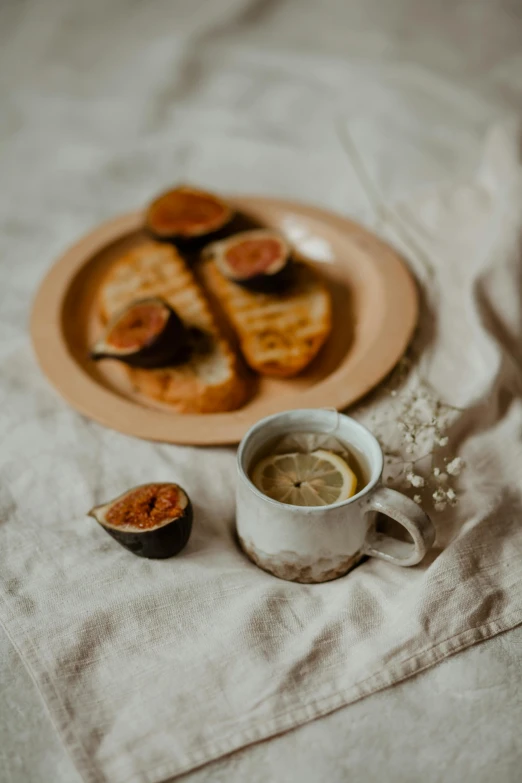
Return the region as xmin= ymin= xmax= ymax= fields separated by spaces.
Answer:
xmin=362 ymin=487 xmax=435 ymax=566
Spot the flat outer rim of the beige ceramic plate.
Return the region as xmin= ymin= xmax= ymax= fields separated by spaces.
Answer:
xmin=30 ymin=195 xmax=419 ymax=446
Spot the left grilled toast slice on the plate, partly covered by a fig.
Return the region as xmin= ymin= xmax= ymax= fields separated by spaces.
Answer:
xmin=98 ymin=241 xmax=248 ymax=413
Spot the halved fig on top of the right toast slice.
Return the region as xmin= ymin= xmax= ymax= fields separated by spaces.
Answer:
xmin=204 ymin=229 xmax=291 ymax=298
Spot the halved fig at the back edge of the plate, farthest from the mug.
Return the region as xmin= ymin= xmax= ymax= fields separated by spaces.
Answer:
xmin=145 ymin=186 xmax=233 ymax=245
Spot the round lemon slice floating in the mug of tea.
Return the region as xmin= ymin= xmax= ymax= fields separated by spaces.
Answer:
xmin=252 ymin=449 xmax=357 ymax=506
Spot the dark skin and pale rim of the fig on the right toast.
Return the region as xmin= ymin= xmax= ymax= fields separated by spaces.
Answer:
xmin=203 ymin=230 xmax=294 ymax=294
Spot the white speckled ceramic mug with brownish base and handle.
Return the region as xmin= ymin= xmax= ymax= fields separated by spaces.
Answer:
xmin=236 ymin=408 xmax=435 ymax=582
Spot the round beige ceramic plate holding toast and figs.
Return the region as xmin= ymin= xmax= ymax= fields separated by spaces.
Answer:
xmin=31 ymin=197 xmax=418 ymax=444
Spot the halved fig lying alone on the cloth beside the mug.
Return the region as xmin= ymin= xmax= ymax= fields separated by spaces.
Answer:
xmin=89 ymin=483 xmax=193 ymax=559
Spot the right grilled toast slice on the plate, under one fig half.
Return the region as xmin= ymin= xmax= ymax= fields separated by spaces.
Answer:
xmin=200 ymin=259 xmax=332 ymax=377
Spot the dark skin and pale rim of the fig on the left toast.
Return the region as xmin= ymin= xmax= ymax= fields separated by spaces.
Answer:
xmin=91 ymin=297 xmax=190 ymax=369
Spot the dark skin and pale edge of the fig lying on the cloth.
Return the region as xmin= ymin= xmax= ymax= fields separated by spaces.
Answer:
xmin=88 ymin=484 xmax=194 ymax=560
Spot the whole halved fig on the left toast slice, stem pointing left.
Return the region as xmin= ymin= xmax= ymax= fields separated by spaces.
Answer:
xmin=91 ymin=297 xmax=189 ymax=368
